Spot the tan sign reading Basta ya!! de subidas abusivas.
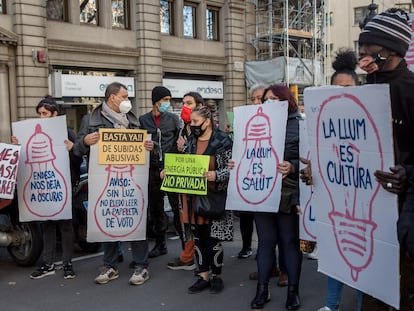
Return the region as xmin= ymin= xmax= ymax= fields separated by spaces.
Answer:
xmin=98 ymin=128 xmax=147 ymax=165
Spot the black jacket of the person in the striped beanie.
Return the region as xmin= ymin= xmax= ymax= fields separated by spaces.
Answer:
xmin=367 ymin=60 xmax=414 ymax=258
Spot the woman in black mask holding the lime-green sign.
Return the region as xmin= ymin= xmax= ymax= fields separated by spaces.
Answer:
xmin=182 ymin=106 xmax=233 ymax=294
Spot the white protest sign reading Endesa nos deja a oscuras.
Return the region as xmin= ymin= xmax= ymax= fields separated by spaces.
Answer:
xmin=12 ymin=116 xmax=72 ymax=221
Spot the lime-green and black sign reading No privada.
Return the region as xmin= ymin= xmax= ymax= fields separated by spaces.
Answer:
xmin=161 ymin=153 xmax=210 ymax=195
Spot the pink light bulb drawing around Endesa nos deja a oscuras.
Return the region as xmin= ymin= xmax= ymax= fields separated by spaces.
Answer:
xmin=23 ymin=124 xmax=68 ymax=218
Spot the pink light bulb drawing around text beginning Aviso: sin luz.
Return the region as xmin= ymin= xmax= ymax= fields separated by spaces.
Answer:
xmin=94 ymin=165 xmax=145 ymax=238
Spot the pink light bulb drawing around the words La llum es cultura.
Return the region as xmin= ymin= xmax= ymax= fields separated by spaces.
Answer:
xmin=316 ymin=94 xmax=384 ymax=281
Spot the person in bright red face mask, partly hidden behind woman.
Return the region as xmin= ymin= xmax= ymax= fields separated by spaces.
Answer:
xmin=167 ymin=92 xmax=204 ymax=270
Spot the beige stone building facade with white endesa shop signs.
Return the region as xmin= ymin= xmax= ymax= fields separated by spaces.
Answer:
xmin=0 ymin=0 xmax=251 ymax=142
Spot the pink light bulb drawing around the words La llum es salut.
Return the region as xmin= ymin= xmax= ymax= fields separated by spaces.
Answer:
xmin=236 ymin=107 xmax=279 ymax=205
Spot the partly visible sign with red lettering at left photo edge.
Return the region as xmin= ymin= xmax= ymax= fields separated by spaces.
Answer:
xmin=0 ymin=143 xmax=20 ymax=199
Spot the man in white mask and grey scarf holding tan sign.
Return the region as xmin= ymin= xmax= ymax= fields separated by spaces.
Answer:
xmin=75 ymin=82 xmax=154 ymax=285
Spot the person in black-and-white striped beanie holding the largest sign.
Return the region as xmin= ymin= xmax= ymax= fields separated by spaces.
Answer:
xmin=359 ymin=8 xmax=414 ymax=311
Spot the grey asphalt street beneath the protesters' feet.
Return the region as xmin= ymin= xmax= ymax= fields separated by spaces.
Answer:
xmin=0 ymin=218 xmax=356 ymax=311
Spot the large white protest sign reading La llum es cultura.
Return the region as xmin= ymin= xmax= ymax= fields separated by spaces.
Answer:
xmin=304 ymin=85 xmax=399 ymax=308
